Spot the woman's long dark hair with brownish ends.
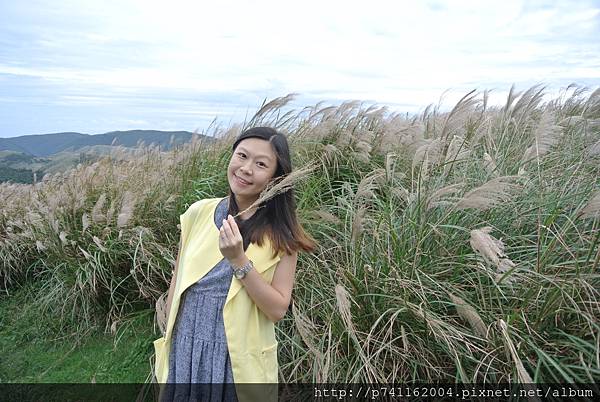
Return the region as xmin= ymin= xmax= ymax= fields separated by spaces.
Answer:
xmin=227 ymin=127 xmax=317 ymax=258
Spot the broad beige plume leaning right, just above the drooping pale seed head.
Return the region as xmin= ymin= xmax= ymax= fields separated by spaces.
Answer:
xmin=456 ymin=176 xmax=521 ymax=211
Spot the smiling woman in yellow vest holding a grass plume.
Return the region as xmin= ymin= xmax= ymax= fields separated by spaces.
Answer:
xmin=154 ymin=127 xmax=316 ymax=401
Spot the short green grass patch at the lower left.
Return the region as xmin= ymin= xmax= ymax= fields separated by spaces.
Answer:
xmin=0 ymin=286 xmax=158 ymax=383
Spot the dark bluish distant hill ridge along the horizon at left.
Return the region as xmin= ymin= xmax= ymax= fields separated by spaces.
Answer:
xmin=0 ymin=130 xmax=214 ymax=157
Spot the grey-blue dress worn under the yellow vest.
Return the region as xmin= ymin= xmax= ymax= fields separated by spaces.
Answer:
xmin=163 ymin=197 xmax=237 ymax=401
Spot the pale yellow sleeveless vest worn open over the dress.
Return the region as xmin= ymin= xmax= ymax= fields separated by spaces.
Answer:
xmin=154 ymin=198 xmax=281 ymax=401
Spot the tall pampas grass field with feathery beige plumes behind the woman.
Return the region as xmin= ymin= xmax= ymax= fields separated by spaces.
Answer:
xmin=0 ymin=86 xmax=600 ymax=383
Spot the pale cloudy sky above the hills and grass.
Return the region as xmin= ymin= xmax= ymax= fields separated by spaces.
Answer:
xmin=0 ymin=0 xmax=600 ymax=137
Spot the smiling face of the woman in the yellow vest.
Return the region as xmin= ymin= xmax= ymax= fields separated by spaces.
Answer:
xmin=227 ymin=138 xmax=277 ymax=200
